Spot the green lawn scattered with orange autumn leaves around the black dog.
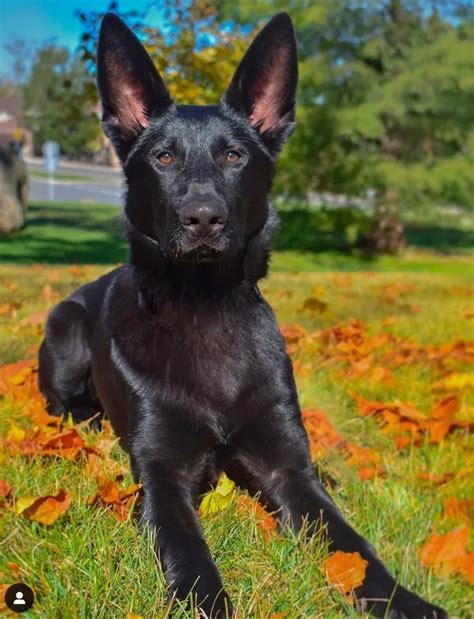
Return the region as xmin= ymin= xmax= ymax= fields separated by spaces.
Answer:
xmin=0 ymin=204 xmax=474 ymax=619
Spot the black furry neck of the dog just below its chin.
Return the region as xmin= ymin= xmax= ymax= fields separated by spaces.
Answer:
xmin=123 ymin=207 xmax=278 ymax=290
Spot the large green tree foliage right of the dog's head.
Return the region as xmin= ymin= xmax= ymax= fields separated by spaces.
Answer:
xmin=221 ymin=0 xmax=474 ymax=207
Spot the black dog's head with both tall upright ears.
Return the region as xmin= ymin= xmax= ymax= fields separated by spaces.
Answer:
xmin=98 ymin=13 xmax=297 ymax=272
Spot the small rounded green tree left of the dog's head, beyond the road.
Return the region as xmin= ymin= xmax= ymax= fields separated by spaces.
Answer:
xmin=23 ymin=44 xmax=100 ymax=157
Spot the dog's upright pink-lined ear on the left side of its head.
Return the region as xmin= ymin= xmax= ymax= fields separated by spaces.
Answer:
xmin=97 ymin=13 xmax=172 ymax=162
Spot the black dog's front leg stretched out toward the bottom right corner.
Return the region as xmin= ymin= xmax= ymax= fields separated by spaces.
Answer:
xmin=230 ymin=410 xmax=448 ymax=619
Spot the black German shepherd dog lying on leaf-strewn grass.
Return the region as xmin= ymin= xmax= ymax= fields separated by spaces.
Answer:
xmin=39 ymin=13 xmax=447 ymax=619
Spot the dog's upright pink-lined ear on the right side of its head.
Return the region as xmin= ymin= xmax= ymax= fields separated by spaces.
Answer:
xmin=223 ymin=13 xmax=298 ymax=153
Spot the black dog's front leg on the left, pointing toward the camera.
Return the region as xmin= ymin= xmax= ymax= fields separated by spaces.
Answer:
xmin=134 ymin=453 xmax=232 ymax=619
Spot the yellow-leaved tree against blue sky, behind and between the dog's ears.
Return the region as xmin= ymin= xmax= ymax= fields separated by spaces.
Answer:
xmin=78 ymin=0 xmax=253 ymax=104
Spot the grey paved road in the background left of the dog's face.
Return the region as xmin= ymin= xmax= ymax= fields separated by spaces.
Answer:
xmin=27 ymin=159 xmax=123 ymax=206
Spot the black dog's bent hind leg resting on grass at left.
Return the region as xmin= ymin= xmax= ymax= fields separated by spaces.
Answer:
xmin=39 ymin=299 xmax=103 ymax=427
